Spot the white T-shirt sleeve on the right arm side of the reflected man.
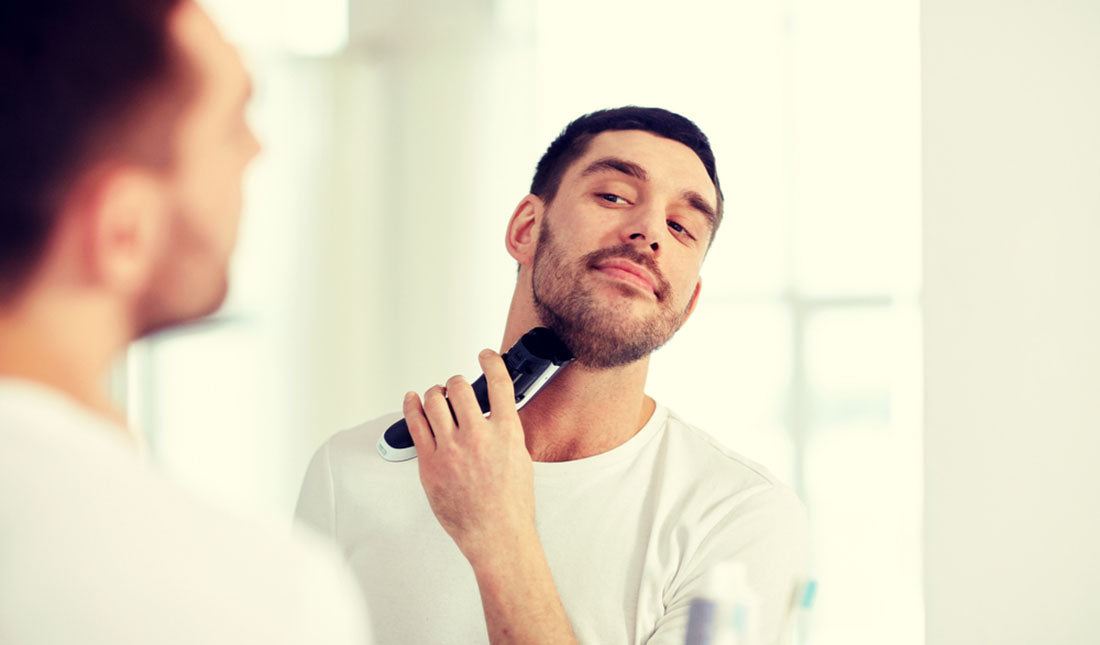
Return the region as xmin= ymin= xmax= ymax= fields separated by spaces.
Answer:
xmin=647 ymin=483 xmax=809 ymax=645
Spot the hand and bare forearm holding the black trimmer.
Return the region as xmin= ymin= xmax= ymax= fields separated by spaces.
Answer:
xmin=405 ymin=350 xmax=576 ymax=645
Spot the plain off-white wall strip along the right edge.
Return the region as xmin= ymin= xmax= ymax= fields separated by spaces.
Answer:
xmin=922 ymin=0 xmax=1100 ymax=645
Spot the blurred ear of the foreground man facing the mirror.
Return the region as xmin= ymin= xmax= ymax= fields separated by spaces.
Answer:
xmin=84 ymin=166 xmax=171 ymax=294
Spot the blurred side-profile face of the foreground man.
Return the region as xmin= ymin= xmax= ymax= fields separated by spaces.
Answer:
xmin=136 ymin=0 xmax=260 ymax=334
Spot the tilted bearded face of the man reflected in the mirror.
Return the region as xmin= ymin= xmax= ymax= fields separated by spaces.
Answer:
xmin=531 ymin=130 xmax=717 ymax=368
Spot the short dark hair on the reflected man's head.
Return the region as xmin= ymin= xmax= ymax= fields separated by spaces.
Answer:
xmin=531 ymin=106 xmax=723 ymax=238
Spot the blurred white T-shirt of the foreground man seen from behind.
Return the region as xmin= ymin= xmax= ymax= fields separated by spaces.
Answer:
xmin=0 ymin=379 xmax=370 ymax=645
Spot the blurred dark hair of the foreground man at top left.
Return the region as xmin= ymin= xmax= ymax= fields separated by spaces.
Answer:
xmin=0 ymin=0 xmax=182 ymax=302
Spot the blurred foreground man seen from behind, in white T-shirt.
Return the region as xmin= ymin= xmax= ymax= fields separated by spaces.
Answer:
xmin=0 ymin=0 xmax=367 ymax=645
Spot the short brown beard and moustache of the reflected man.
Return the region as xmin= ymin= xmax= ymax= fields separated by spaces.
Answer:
xmin=531 ymin=220 xmax=689 ymax=370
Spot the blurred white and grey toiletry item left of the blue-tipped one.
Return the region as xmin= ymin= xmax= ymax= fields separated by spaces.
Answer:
xmin=684 ymin=561 xmax=760 ymax=645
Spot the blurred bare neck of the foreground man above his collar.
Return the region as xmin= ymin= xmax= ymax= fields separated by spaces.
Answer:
xmin=0 ymin=292 xmax=129 ymax=435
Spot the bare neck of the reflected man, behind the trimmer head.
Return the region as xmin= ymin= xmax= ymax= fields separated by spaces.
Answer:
xmin=501 ymin=280 xmax=656 ymax=461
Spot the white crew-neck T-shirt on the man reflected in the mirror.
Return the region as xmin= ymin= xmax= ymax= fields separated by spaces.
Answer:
xmin=297 ymin=406 xmax=807 ymax=645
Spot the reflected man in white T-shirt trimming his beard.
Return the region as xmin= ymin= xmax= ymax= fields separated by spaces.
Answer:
xmin=298 ymin=107 xmax=806 ymax=645
